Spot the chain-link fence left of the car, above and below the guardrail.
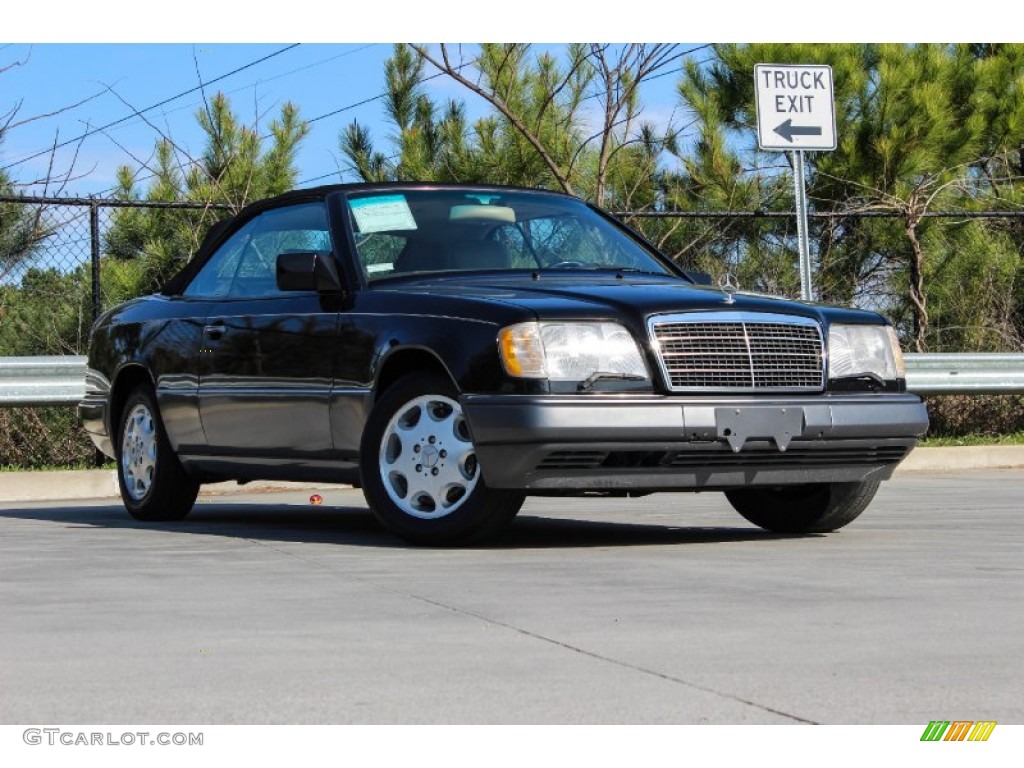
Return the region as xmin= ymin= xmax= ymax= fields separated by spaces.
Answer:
xmin=0 ymin=197 xmax=229 ymax=469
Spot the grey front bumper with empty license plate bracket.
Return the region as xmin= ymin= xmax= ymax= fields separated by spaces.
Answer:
xmin=461 ymin=393 xmax=928 ymax=493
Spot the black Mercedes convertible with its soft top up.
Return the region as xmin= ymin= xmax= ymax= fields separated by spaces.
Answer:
xmin=80 ymin=184 xmax=928 ymax=544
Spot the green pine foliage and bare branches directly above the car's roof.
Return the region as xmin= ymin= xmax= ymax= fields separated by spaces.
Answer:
xmin=340 ymin=44 xmax=673 ymax=207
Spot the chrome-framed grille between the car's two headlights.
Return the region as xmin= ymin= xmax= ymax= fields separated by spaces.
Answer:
xmin=650 ymin=312 xmax=824 ymax=392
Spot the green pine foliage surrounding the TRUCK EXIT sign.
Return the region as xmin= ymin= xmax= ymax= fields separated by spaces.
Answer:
xmin=676 ymin=43 xmax=1024 ymax=351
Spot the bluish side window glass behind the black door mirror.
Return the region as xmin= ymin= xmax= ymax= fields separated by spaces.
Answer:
xmin=184 ymin=203 xmax=333 ymax=298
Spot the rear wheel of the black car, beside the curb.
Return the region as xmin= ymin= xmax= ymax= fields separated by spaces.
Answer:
xmin=117 ymin=385 xmax=200 ymax=521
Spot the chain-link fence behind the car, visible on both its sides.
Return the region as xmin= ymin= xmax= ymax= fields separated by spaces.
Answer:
xmin=0 ymin=198 xmax=1024 ymax=468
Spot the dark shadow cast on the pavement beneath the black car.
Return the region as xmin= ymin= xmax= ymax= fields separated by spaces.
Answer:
xmin=0 ymin=503 xmax=816 ymax=550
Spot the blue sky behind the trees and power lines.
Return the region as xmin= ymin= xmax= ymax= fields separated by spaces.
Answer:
xmin=0 ymin=43 xmax=710 ymax=195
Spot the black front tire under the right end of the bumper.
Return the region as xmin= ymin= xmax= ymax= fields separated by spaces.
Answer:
xmin=725 ymin=480 xmax=880 ymax=534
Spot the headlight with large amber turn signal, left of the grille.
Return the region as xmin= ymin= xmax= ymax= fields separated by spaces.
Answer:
xmin=498 ymin=323 xmax=647 ymax=381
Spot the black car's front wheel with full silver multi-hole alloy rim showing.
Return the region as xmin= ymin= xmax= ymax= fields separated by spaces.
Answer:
xmin=359 ymin=373 xmax=525 ymax=546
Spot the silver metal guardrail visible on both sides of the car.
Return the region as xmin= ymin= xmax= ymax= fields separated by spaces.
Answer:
xmin=0 ymin=353 xmax=1024 ymax=408
